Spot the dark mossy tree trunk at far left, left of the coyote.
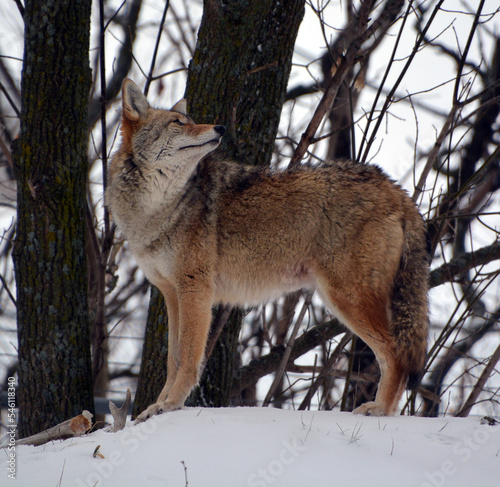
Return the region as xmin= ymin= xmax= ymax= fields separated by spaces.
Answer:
xmin=14 ymin=0 xmax=93 ymax=436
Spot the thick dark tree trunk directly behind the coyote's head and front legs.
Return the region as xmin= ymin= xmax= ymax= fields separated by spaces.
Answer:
xmin=136 ymin=0 xmax=304 ymax=416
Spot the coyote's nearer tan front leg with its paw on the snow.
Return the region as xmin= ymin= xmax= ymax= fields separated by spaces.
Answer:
xmin=136 ymin=283 xmax=213 ymax=422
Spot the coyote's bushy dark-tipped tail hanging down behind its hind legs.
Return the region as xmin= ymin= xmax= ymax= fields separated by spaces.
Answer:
xmin=391 ymin=201 xmax=429 ymax=389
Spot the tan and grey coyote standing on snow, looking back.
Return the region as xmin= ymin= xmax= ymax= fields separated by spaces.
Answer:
xmin=105 ymin=79 xmax=429 ymax=421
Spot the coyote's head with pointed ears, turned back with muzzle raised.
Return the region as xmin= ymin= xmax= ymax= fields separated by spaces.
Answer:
xmin=121 ymin=79 xmax=225 ymax=178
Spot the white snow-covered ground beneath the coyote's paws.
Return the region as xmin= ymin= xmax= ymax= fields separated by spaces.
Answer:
xmin=0 ymin=408 xmax=500 ymax=487
